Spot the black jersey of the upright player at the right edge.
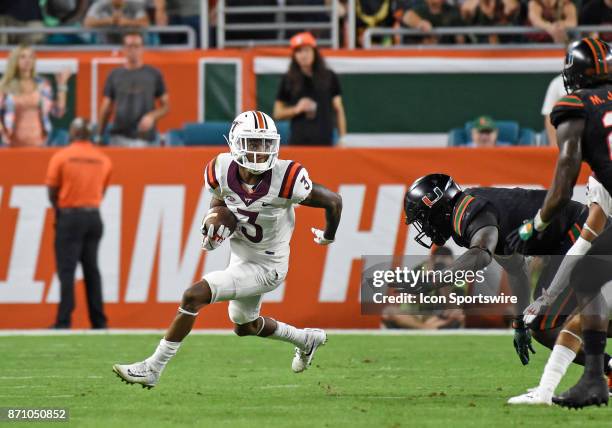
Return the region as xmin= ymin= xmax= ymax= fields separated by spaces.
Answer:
xmin=550 ymin=84 xmax=612 ymax=194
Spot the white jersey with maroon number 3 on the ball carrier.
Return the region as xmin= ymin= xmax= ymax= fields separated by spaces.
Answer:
xmin=204 ymin=153 xmax=312 ymax=260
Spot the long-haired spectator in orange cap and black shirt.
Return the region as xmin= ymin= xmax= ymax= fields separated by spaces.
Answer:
xmin=274 ymin=33 xmax=346 ymax=146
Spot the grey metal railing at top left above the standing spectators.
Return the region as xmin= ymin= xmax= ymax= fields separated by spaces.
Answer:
xmin=0 ymin=25 xmax=196 ymax=51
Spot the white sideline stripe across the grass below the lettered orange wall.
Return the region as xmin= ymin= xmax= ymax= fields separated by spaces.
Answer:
xmin=0 ymin=328 xmax=513 ymax=337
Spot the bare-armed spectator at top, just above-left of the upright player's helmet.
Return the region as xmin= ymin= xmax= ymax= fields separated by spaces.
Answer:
xmin=528 ymin=0 xmax=578 ymax=43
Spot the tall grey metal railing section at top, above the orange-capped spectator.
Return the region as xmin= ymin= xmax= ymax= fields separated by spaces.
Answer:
xmin=214 ymin=0 xmax=340 ymax=49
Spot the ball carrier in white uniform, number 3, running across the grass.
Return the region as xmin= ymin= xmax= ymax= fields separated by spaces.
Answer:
xmin=113 ymin=111 xmax=342 ymax=388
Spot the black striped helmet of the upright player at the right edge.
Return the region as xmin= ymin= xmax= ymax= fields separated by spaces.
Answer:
xmin=562 ymin=37 xmax=612 ymax=93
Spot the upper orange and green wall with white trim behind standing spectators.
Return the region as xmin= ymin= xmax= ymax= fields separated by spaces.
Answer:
xmin=0 ymin=48 xmax=562 ymax=132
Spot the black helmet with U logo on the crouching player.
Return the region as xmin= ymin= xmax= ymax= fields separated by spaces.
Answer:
xmin=404 ymin=174 xmax=461 ymax=248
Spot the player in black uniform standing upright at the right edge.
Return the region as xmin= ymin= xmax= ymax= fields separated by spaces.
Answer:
xmin=511 ymin=38 xmax=612 ymax=408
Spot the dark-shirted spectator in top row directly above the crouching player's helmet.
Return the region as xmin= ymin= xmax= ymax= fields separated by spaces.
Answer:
xmin=402 ymin=0 xmax=465 ymax=44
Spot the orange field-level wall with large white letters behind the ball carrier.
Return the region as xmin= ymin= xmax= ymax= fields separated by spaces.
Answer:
xmin=0 ymin=148 xmax=588 ymax=329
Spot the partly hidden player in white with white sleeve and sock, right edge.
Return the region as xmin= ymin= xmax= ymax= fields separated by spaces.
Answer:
xmin=508 ymin=176 xmax=612 ymax=405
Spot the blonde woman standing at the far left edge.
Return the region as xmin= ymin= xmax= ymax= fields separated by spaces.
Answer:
xmin=0 ymin=45 xmax=70 ymax=147
